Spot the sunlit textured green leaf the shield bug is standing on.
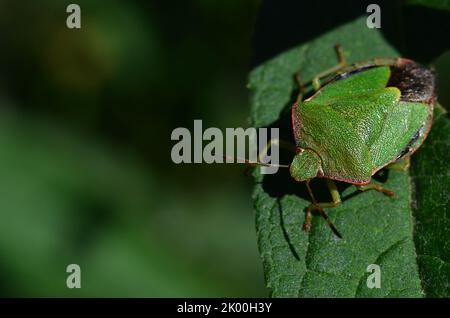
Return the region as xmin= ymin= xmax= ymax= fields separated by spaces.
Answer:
xmin=249 ymin=17 xmax=448 ymax=297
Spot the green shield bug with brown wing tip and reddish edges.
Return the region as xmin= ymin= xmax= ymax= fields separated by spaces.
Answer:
xmin=258 ymin=45 xmax=436 ymax=238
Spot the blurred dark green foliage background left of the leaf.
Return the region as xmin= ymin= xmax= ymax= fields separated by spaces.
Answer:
xmin=0 ymin=0 xmax=266 ymax=297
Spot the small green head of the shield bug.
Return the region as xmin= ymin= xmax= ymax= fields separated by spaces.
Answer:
xmin=290 ymin=149 xmax=321 ymax=182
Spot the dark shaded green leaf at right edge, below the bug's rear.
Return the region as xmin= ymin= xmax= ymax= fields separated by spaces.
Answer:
xmin=411 ymin=105 xmax=450 ymax=297
